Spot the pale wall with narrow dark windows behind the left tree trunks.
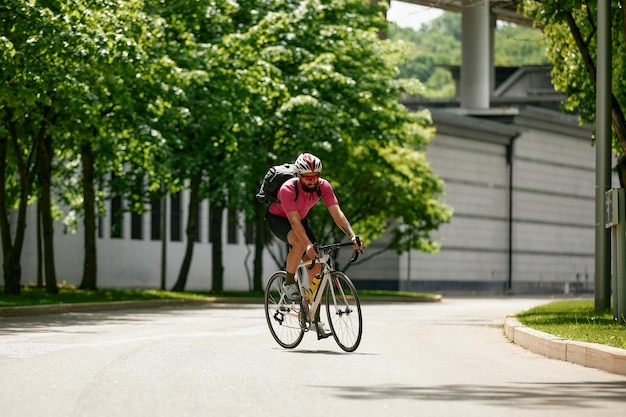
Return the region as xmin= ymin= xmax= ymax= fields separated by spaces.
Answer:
xmin=10 ymin=196 xmax=277 ymax=291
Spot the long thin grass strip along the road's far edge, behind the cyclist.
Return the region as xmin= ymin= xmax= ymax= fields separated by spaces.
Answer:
xmin=0 ymin=286 xmax=436 ymax=307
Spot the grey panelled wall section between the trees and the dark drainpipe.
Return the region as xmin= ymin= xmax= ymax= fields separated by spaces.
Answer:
xmin=400 ymin=134 xmax=508 ymax=289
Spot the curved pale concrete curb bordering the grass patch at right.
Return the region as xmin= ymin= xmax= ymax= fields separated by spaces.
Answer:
xmin=504 ymin=317 xmax=626 ymax=375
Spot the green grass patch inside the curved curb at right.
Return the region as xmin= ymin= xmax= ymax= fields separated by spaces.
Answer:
xmin=516 ymin=300 xmax=626 ymax=349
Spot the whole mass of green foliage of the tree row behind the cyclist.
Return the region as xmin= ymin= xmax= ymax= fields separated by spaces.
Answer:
xmin=0 ymin=0 xmax=453 ymax=288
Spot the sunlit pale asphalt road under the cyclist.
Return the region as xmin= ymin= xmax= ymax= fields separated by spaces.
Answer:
xmin=0 ymin=298 xmax=626 ymax=417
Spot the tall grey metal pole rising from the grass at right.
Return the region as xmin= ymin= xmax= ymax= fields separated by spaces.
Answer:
xmin=595 ymin=1 xmax=611 ymax=310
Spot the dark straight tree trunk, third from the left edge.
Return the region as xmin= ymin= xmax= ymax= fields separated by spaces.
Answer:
xmin=80 ymin=142 xmax=98 ymax=290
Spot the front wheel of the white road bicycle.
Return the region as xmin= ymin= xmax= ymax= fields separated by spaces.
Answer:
xmin=326 ymin=271 xmax=363 ymax=352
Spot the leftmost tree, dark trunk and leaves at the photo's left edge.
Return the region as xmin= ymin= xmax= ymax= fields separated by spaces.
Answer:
xmin=0 ymin=1 xmax=52 ymax=294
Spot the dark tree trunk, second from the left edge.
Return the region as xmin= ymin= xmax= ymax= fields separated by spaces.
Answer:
xmin=39 ymin=135 xmax=59 ymax=294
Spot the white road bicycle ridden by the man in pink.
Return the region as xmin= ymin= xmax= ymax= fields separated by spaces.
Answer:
xmin=264 ymin=242 xmax=363 ymax=352
